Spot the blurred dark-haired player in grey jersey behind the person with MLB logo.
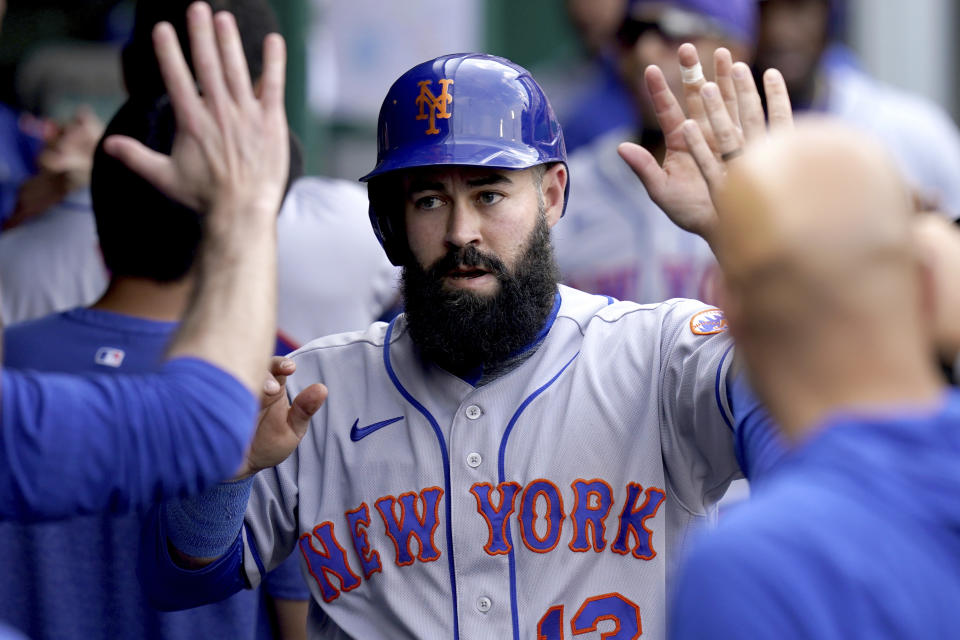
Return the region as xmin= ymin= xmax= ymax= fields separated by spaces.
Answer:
xmin=0 ymin=0 xmax=398 ymax=340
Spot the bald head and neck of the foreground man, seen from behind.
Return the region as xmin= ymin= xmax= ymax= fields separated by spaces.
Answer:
xmin=718 ymin=120 xmax=929 ymax=438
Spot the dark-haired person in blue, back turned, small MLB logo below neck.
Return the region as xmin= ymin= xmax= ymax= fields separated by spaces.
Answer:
xmin=0 ymin=95 xmax=309 ymax=640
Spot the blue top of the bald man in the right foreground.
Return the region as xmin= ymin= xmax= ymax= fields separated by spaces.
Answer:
xmin=670 ymin=392 xmax=960 ymax=640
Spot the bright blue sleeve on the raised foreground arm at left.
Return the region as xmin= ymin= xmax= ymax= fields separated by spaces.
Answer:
xmin=0 ymin=358 xmax=257 ymax=521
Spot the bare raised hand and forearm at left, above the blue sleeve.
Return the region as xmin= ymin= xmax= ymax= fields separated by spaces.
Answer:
xmin=105 ymin=3 xmax=289 ymax=394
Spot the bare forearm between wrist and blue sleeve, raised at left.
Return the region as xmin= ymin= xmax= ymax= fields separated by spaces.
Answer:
xmin=170 ymin=201 xmax=277 ymax=393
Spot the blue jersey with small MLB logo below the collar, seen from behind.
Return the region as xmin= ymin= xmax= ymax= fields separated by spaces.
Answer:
xmin=0 ymin=309 xmax=306 ymax=639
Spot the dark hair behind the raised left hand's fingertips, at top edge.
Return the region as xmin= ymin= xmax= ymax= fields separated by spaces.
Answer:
xmin=122 ymin=0 xmax=279 ymax=97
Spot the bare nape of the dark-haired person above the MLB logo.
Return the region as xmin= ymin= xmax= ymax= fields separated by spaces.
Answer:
xmin=91 ymin=276 xmax=193 ymax=322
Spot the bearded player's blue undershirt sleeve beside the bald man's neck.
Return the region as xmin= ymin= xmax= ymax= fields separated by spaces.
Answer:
xmin=727 ymin=373 xmax=787 ymax=482
